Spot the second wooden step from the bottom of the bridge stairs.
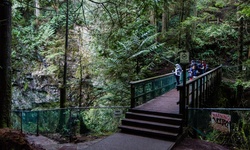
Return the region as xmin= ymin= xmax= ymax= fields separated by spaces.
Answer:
xmin=122 ymin=118 xmax=181 ymax=133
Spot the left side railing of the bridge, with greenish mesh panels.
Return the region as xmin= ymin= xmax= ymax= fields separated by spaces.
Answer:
xmin=130 ymin=73 xmax=176 ymax=108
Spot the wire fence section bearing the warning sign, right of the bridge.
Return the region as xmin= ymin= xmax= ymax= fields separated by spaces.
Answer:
xmin=188 ymin=108 xmax=250 ymax=149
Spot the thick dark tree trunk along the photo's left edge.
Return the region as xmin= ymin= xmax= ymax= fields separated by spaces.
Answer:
xmin=0 ymin=0 xmax=11 ymax=128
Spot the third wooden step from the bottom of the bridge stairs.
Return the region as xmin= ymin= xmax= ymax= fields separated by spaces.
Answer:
xmin=125 ymin=112 xmax=182 ymax=125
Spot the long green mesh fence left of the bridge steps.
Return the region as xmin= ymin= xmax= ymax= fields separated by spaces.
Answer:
xmin=11 ymin=107 xmax=129 ymax=141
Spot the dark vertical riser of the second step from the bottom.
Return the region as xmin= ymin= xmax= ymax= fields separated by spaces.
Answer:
xmin=122 ymin=120 xmax=181 ymax=133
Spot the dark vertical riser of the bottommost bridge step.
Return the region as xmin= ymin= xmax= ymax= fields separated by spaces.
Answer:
xmin=119 ymin=128 xmax=177 ymax=141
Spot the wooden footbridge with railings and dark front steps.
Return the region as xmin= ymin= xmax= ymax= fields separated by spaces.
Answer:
xmin=119 ymin=66 xmax=222 ymax=142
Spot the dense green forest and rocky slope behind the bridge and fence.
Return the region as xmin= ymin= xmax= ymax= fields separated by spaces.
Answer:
xmin=5 ymin=0 xmax=250 ymax=109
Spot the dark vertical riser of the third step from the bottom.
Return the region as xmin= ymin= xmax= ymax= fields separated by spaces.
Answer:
xmin=126 ymin=114 xmax=182 ymax=125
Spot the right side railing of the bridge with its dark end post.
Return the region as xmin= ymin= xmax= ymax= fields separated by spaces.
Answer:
xmin=178 ymin=65 xmax=222 ymax=124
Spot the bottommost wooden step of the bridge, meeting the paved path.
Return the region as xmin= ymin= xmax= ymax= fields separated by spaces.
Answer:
xmin=119 ymin=125 xmax=178 ymax=141
